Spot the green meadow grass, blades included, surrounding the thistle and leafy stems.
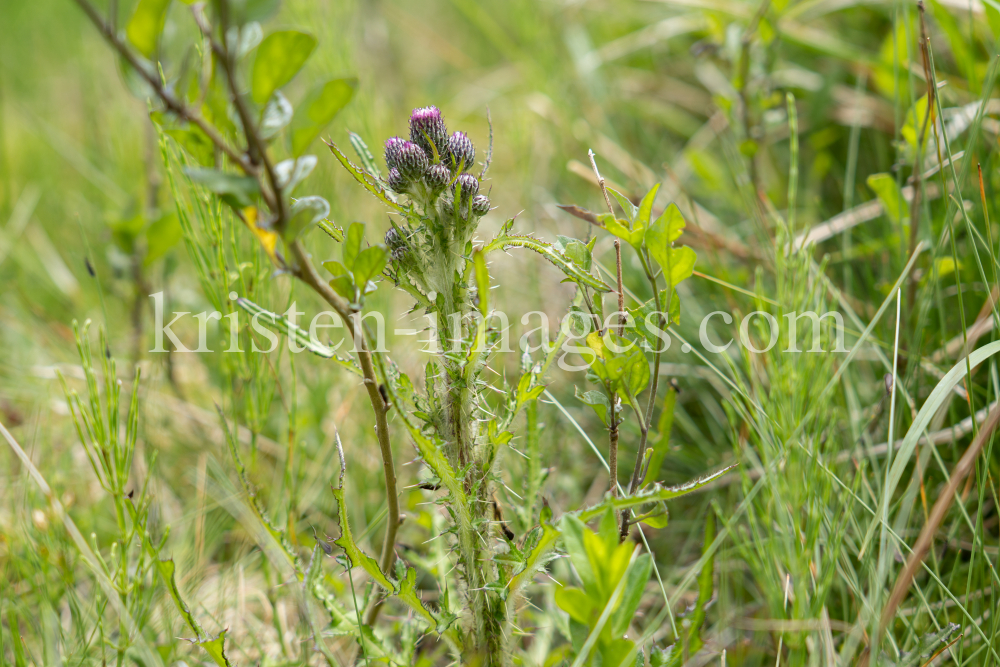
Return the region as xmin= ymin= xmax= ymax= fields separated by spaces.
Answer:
xmin=0 ymin=0 xmax=1000 ymax=667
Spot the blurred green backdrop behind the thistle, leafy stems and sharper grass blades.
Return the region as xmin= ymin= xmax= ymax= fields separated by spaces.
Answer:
xmin=0 ymin=0 xmax=1000 ymax=665
